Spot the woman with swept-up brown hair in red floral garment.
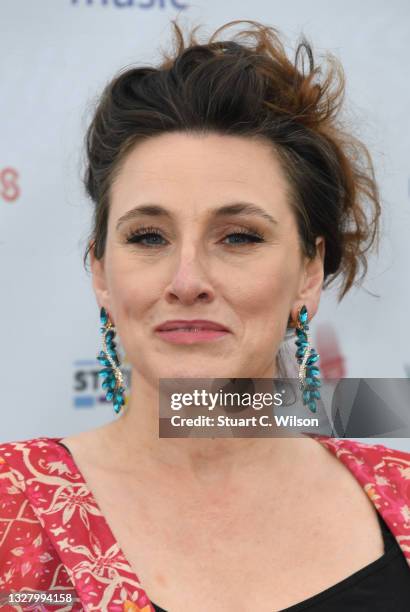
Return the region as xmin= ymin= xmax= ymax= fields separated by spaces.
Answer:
xmin=0 ymin=22 xmax=410 ymax=612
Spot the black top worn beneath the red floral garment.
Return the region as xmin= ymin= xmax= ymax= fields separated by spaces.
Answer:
xmin=55 ymin=442 xmax=410 ymax=612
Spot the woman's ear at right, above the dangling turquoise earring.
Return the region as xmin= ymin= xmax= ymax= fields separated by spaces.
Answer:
xmin=292 ymin=236 xmax=325 ymax=321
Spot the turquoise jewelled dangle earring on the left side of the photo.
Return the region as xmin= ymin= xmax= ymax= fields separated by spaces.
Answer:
xmin=97 ymin=308 xmax=126 ymax=414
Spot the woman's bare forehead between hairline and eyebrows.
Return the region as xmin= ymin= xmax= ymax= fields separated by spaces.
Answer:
xmin=110 ymin=132 xmax=289 ymax=217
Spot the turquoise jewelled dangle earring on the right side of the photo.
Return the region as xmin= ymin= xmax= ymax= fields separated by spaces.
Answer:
xmin=295 ymin=305 xmax=321 ymax=412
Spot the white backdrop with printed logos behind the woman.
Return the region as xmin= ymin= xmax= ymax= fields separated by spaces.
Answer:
xmin=0 ymin=0 xmax=410 ymax=450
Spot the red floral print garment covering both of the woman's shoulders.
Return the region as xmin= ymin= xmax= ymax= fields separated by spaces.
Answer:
xmin=0 ymin=436 xmax=410 ymax=612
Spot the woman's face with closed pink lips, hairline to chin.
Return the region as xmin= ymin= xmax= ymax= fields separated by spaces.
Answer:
xmin=91 ymin=133 xmax=324 ymax=380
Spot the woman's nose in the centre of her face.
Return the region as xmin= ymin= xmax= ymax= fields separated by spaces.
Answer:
xmin=166 ymin=249 xmax=215 ymax=306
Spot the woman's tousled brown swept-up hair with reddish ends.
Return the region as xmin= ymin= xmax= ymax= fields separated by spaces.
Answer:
xmin=84 ymin=20 xmax=380 ymax=301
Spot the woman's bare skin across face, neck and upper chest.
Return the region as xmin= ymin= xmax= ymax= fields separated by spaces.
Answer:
xmin=63 ymin=133 xmax=383 ymax=612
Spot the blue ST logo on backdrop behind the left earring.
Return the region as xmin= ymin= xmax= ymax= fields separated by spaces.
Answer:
xmin=73 ymin=358 xmax=131 ymax=409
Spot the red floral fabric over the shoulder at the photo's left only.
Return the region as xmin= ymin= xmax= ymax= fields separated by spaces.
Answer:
xmin=0 ymin=438 xmax=153 ymax=612
